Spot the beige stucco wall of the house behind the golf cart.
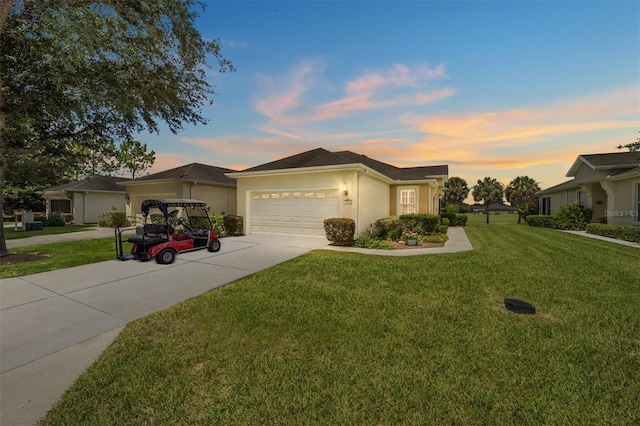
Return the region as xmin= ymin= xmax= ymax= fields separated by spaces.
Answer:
xmin=126 ymin=182 xmax=237 ymax=218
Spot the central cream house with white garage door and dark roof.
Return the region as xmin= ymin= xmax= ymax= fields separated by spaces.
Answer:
xmin=227 ymin=148 xmax=449 ymax=236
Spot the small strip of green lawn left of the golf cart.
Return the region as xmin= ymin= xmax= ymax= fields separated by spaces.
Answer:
xmin=0 ymin=238 xmax=126 ymax=278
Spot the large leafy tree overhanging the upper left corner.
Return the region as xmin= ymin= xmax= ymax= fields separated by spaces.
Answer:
xmin=0 ymin=0 xmax=233 ymax=256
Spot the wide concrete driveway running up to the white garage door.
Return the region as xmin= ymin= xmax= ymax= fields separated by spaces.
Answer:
xmin=0 ymin=235 xmax=328 ymax=426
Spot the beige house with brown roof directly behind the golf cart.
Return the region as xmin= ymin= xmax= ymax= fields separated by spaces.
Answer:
xmin=119 ymin=163 xmax=236 ymax=218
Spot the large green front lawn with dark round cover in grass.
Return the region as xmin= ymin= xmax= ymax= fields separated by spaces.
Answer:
xmin=42 ymin=221 xmax=640 ymax=425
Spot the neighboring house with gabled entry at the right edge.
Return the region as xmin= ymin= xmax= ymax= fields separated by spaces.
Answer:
xmin=538 ymin=152 xmax=640 ymax=225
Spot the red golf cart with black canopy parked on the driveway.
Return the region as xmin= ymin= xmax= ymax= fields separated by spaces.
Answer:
xmin=115 ymin=199 xmax=220 ymax=265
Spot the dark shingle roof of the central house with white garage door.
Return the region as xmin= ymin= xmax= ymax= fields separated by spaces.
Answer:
xmin=238 ymin=148 xmax=449 ymax=180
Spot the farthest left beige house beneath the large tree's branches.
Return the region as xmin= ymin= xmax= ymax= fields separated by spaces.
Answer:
xmin=41 ymin=176 xmax=127 ymax=223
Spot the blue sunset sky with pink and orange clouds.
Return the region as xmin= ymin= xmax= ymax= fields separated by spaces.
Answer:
xmin=139 ymin=1 xmax=640 ymax=193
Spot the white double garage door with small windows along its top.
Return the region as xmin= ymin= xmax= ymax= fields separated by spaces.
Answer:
xmin=249 ymin=189 xmax=340 ymax=236
